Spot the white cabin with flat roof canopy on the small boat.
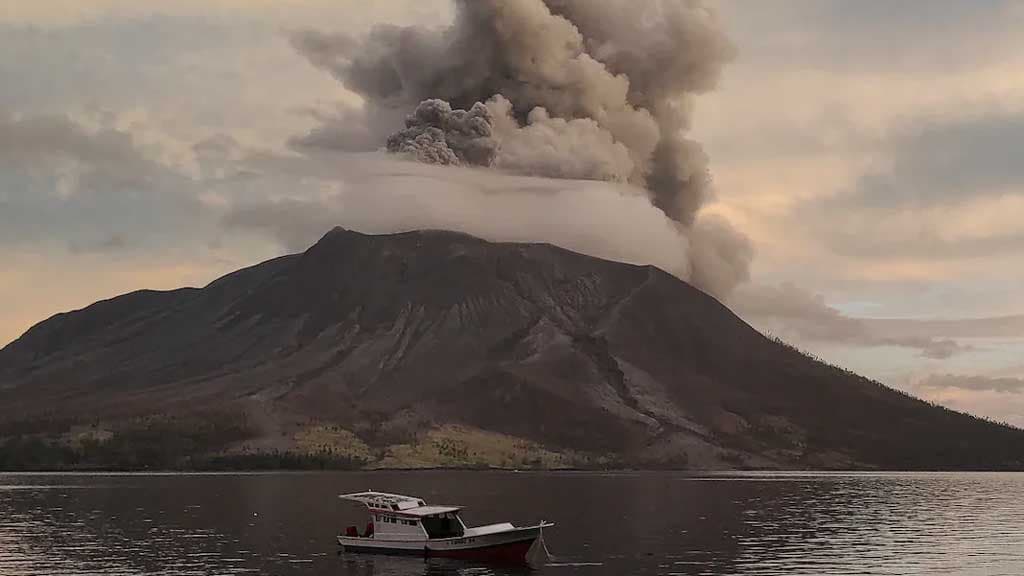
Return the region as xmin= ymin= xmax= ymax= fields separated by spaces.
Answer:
xmin=339 ymin=492 xmax=466 ymax=540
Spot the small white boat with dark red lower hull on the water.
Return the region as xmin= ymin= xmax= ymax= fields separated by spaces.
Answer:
xmin=338 ymin=491 xmax=554 ymax=564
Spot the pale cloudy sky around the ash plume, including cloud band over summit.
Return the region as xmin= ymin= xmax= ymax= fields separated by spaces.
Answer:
xmin=0 ymin=0 xmax=1024 ymax=426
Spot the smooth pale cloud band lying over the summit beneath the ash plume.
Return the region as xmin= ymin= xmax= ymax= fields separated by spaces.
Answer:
xmin=223 ymin=154 xmax=690 ymax=278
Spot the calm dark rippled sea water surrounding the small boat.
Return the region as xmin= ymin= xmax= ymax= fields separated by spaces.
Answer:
xmin=0 ymin=471 xmax=1024 ymax=576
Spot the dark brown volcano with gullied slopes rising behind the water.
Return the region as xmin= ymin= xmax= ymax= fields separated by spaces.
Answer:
xmin=0 ymin=229 xmax=1024 ymax=468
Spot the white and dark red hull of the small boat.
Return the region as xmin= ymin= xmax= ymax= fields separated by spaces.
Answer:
xmin=338 ymin=526 xmax=542 ymax=563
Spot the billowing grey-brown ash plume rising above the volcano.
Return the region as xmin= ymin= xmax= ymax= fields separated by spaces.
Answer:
xmin=293 ymin=0 xmax=752 ymax=295
